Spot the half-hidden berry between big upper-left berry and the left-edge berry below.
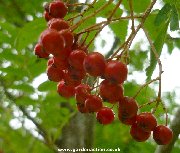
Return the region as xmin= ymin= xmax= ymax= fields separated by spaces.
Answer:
xmin=53 ymin=57 xmax=69 ymax=70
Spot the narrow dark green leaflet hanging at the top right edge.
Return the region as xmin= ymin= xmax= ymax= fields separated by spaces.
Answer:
xmin=170 ymin=5 xmax=179 ymax=31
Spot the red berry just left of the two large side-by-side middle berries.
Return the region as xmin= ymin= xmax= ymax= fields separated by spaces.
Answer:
xmin=68 ymin=50 xmax=86 ymax=70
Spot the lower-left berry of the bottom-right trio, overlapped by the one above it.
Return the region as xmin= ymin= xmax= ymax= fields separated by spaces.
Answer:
xmin=130 ymin=124 xmax=151 ymax=142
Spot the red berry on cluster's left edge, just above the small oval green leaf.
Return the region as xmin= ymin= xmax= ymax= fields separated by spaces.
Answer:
xmin=47 ymin=65 xmax=64 ymax=82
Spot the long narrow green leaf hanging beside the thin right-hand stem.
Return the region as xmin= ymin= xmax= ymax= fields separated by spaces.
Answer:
xmin=146 ymin=22 xmax=169 ymax=81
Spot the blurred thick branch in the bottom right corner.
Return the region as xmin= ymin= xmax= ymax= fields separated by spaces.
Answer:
xmin=155 ymin=108 xmax=180 ymax=153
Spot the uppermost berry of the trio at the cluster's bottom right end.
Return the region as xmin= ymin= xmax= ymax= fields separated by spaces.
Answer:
xmin=136 ymin=112 xmax=157 ymax=132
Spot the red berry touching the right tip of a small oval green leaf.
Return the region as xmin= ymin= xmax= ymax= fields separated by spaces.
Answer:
xmin=57 ymin=81 xmax=75 ymax=98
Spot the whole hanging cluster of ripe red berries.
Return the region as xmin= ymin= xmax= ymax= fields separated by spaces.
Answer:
xmin=34 ymin=0 xmax=172 ymax=145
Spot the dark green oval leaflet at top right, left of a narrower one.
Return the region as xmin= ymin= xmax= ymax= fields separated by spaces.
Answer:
xmin=154 ymin=3 xmax=171 ymax=26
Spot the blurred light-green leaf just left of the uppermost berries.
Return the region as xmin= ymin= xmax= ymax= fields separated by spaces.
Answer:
xmin=14 ymin=18 xmax=46 ymax=50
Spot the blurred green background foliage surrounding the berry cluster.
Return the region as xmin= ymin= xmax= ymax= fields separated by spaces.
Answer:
xmin=0 ymin=0 xmax=180 ymax=153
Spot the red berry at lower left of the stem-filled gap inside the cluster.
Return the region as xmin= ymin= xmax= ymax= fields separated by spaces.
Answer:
xmin=75 ymin=84 xmax=91 ymax=104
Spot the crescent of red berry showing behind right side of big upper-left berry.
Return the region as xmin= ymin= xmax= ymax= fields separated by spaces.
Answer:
xmin=59 ymin=29 xmax=74 ymax=48
